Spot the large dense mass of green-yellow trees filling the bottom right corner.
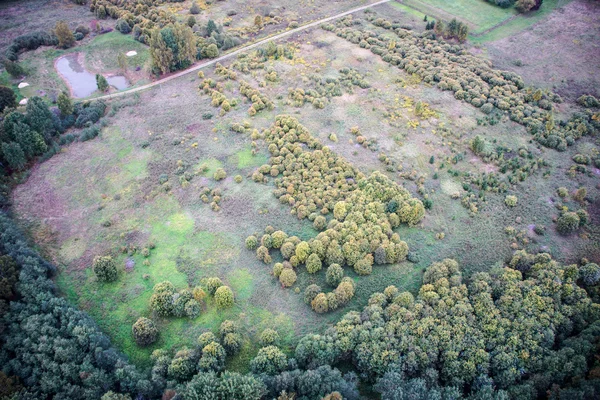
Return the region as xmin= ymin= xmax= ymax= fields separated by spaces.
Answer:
xmin=295 ymin=254 xmax=600 ymax=399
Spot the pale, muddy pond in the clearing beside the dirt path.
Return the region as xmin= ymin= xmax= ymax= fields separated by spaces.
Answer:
xmin=55 ymin=53 xmax=129 ymax=98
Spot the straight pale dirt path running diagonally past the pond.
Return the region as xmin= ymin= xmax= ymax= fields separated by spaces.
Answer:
xmin=90 ymin=0 xmax=391 ymax=100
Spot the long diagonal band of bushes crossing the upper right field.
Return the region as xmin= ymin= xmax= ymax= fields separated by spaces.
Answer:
xmin=323 ymin=17 xmax=600 ymax=150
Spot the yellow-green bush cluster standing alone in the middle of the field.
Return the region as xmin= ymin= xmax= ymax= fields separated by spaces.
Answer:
xmin=240 ymin=115 xmax=425 ymax=309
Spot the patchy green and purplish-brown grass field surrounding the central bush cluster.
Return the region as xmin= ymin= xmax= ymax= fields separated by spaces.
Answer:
xmin=13 ymin=1 xmax=600 ymax=371
